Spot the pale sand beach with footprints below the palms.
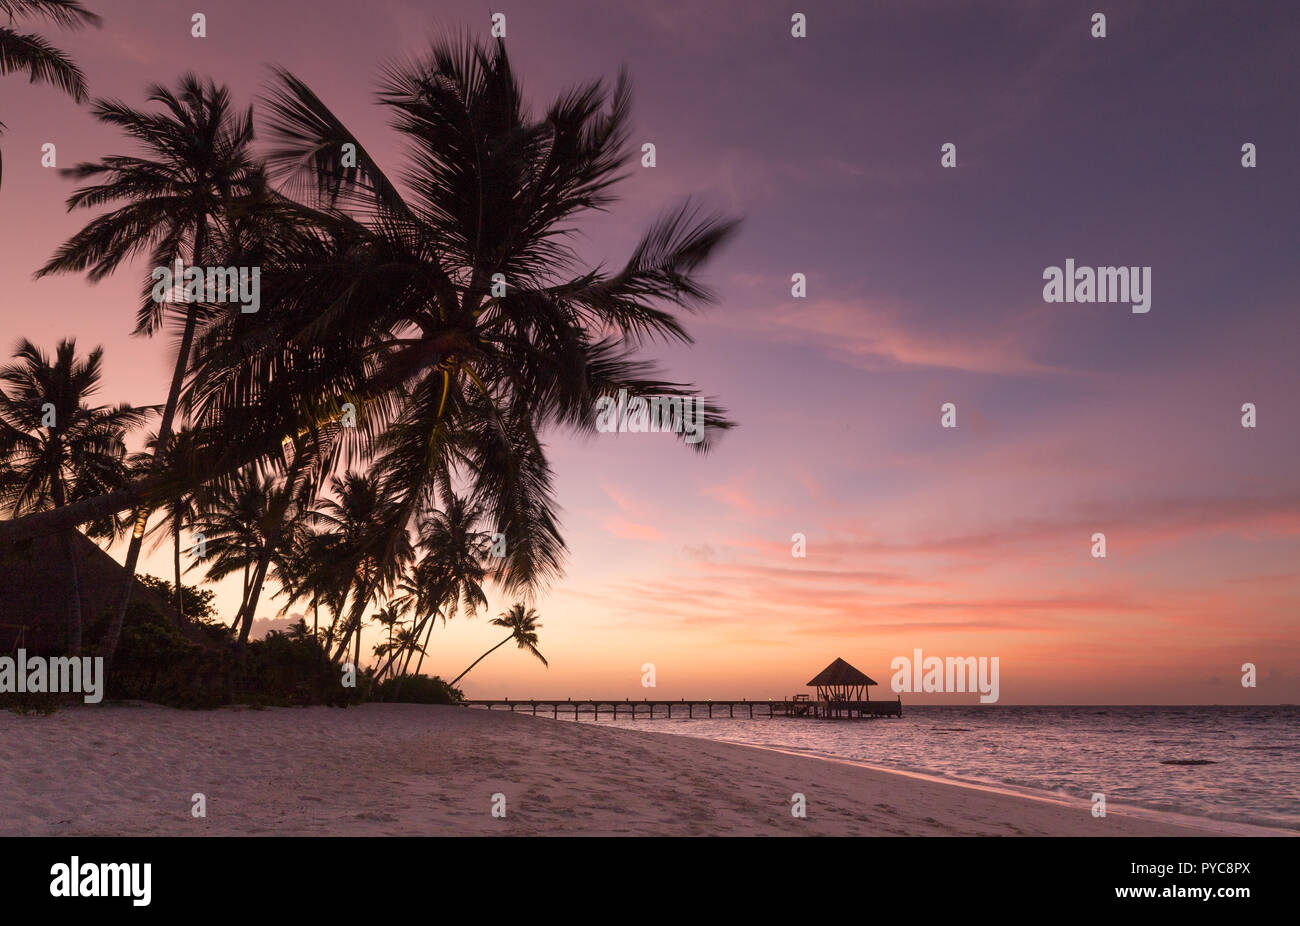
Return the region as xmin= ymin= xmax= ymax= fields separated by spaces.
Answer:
xmin=0 ymin=704 xmax=1258 ymax=836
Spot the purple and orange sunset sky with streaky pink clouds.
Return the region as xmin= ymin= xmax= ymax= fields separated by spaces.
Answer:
xmin=0 ymin=0 xmax=1300 ymax=704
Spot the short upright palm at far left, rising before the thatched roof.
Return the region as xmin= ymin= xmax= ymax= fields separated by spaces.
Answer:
xmin=0 ymin=339 xmax=151 ymax=655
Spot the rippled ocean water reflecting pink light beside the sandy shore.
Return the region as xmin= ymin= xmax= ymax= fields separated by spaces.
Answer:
xmin=585 ymin=705 xmax=1300 ymax=831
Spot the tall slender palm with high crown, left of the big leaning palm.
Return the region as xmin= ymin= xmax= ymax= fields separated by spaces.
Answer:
xmin=36 ymin=74 xmax=263 ymax=659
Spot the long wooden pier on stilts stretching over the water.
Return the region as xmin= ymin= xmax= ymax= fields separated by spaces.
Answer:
xmin=460 ymin=697 xmax=902 ymax=721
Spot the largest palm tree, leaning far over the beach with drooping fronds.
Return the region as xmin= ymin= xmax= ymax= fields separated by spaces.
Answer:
xmin=0 ymin=39 xmax=736 ymax=608
